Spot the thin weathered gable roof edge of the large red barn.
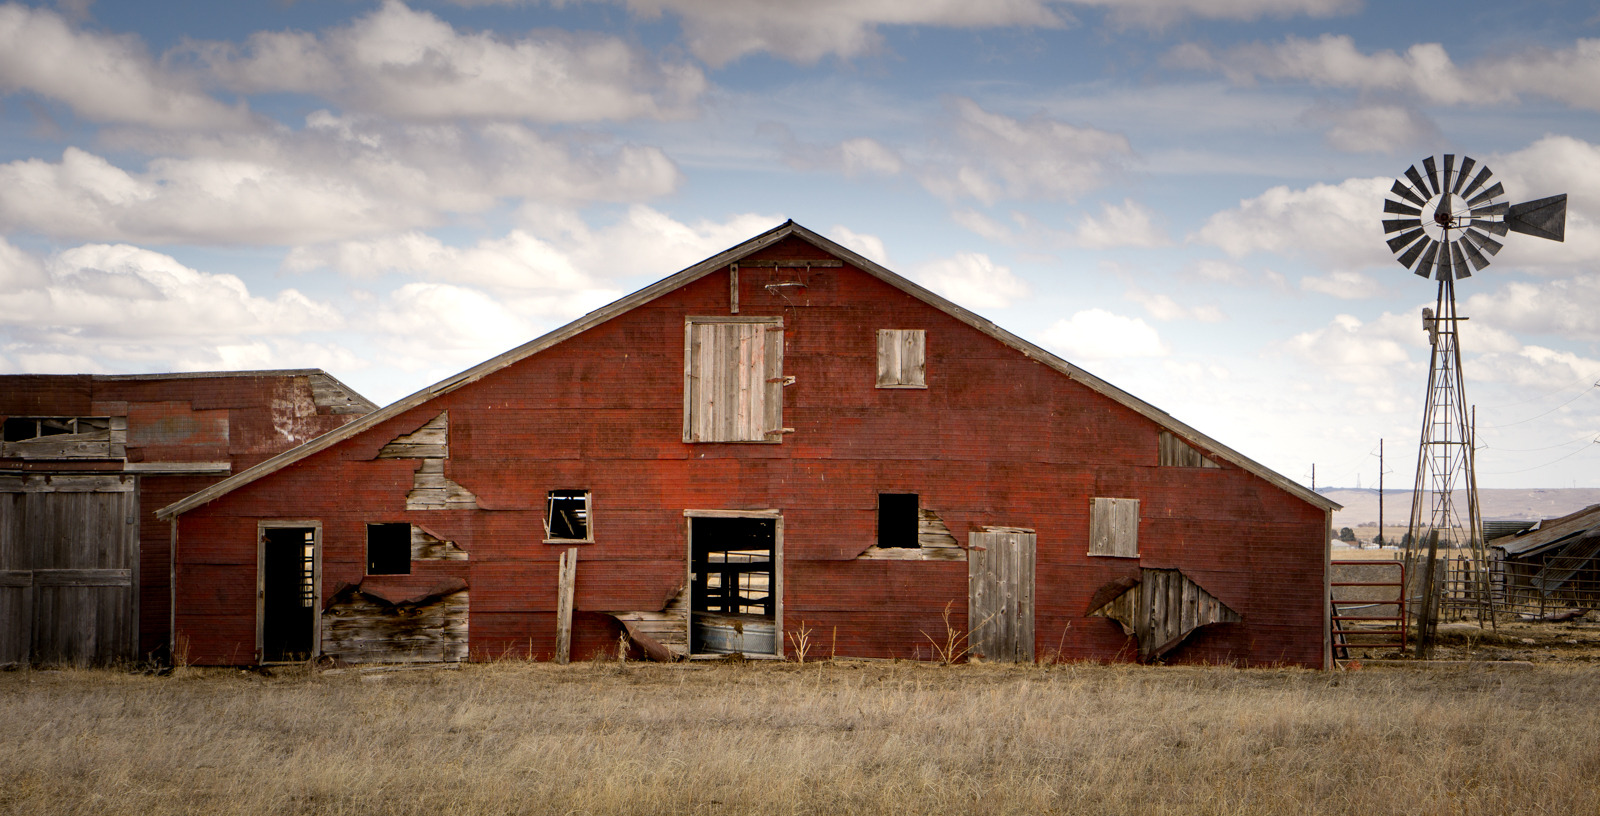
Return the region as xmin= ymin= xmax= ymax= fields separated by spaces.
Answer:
xmin=155 ymin=221 xmax=1339 ymax=518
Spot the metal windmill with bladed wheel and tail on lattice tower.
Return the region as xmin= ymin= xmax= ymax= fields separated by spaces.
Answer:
xmin=1384 ymin=154 xmax=1566 ymax=654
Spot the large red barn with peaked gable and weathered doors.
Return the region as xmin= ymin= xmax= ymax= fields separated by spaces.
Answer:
xmin=158 ymin=222 xmax=1336 ymax=666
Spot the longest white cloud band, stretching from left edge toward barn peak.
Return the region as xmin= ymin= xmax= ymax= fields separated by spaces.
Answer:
xmin=0 ymin=112 xmax=680 ymax=243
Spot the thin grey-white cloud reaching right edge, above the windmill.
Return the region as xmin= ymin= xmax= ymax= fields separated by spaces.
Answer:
xmin=1166 ymin=34 xmax=1600 ymax=110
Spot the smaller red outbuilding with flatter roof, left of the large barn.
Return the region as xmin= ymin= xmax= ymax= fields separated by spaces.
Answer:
xmin=0 ymin=370 xmax=376 ymax=664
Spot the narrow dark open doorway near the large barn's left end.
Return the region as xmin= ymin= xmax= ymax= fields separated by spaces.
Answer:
xmin=256 ymin=522 xmax=322 ymax=662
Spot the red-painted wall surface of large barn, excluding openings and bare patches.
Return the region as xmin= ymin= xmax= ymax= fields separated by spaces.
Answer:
xmin=178 ymin=238 xmax=1326 ymax=666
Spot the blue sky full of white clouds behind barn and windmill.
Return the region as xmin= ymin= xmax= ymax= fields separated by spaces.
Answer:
xmin=0 ymin=0 xmax=1600 ymax=488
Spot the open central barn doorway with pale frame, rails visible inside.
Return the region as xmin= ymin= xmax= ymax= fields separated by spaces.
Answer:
xmin=688 ymin=510 xmax=782 ymax=658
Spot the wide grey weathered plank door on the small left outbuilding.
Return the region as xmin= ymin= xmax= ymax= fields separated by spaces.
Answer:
xmin=0 ymin=475 xmax=139 ymax=666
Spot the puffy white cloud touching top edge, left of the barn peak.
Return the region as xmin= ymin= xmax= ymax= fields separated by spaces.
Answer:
xmin=195 ymin=0 xmax=706 ymax=122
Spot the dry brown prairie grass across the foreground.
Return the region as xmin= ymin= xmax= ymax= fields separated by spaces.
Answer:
xmin=0 ymin=661 xmax=1600 ymax=816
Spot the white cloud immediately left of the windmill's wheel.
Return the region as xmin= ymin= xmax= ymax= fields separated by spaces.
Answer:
xmin=1189 ymin=178 xmax=1398 ymax=270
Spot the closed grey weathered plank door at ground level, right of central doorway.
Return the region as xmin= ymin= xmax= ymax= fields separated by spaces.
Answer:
xmin=966 ymin=528 xmax=1037 ymax=662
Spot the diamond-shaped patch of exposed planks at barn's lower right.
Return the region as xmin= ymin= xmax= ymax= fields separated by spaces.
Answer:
xmin=1088 ymin=568 xmax=1243 ymax=661
